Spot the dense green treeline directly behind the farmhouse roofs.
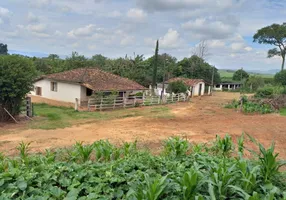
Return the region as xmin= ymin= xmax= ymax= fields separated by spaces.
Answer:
xmin=26 ymin=52 xmax=220 ymax=86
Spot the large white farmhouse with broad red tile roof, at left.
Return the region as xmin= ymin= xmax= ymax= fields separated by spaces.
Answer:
xmin=31 ymin=68 xmax=147 ymax=105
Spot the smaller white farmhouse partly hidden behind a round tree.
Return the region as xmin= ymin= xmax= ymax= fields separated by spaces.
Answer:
xmin=155 ymin=78 xmax=210 ymax=96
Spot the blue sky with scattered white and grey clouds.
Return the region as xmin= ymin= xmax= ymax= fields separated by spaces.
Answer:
xmin=0 ymin=0 xmax=286 ymax=71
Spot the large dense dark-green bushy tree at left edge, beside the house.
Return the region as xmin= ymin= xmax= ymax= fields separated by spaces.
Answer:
xmin=0 ymin=55 xmax=36 ymax=121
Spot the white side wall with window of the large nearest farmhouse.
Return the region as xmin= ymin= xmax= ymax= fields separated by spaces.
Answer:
xmin=31 ymin=79 xmax=82 ymax=103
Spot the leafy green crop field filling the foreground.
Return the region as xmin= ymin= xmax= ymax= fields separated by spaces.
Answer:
xmin=0 ymin=135 xmax=286 ymax=200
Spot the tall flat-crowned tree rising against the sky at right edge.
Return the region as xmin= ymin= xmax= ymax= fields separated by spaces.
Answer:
xmin=253 ymin=23 xmax=286 ymax=71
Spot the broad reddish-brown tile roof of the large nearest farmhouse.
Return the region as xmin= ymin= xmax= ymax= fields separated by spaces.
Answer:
xmin=41 ymin=68 xmax=147 ymax=91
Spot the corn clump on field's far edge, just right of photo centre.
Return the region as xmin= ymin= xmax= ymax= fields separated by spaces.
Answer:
xmin=164 ymin=137 xmax=190 ymax=157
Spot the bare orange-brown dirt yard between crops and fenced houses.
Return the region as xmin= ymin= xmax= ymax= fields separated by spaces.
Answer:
xmin=0 ymin=93 xmax=286 ymax=159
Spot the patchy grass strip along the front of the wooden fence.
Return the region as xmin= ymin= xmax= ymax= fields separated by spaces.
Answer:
xmin=29 ymin=104 xmax=173 ymax=130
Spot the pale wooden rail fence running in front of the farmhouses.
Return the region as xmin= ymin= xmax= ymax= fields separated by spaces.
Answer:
xmin=88 ymin=94 xmax=187 ymax=111
